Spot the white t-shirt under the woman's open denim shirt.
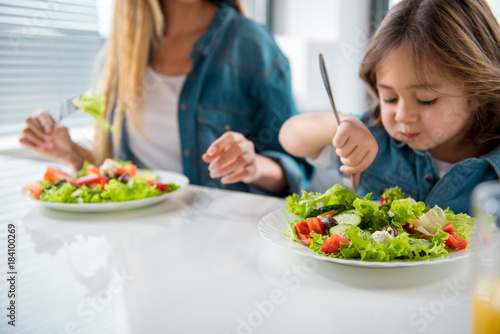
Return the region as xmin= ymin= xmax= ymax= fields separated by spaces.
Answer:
xmin=125 ymin=66 xmax=186 ymax=173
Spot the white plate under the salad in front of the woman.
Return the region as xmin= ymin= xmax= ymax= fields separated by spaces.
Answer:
xmin=21 ymin=170 xmax=189 ymax=212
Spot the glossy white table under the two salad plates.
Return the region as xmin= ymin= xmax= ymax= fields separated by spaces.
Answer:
xmin=0 ymin=156 xmax=480 ymax=334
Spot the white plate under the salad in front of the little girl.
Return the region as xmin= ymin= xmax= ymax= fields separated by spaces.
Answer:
xmin=258 ymin=209 xmax=473 ymax=268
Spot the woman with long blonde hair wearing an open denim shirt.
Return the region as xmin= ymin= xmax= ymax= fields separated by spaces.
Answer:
xmin=20 ymin=0 xmax=311 ymax=195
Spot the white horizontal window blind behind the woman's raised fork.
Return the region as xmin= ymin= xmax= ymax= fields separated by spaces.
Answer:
xmin=0 ymin=0 xmax=103 ymax=136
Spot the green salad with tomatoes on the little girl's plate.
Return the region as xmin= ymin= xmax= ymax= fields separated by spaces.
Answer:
xmin=286 ymin=185 xmax=474 ymax=261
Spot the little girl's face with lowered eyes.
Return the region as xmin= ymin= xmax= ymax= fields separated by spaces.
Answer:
xmin=375 ymin=48 xmax=472 ymax=160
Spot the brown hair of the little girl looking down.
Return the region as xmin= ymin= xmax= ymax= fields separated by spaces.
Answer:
xmin=360 ymin=0 xmax=500 ymax=145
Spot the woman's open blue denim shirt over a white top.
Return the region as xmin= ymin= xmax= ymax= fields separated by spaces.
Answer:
xmin=112 ymin=5 xmax=312 ymax=195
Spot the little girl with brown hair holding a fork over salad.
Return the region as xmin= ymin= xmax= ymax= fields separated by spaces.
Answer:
xmin=280 ymin=0 xmax=500 ymax=213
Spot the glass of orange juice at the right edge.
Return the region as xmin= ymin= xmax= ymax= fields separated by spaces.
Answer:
xmin=472 ymin=181 xmax=500 ymax=334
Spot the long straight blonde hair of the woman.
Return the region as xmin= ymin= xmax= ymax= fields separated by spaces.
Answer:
xmin=93 ymin=0 xmax=243 ymax=164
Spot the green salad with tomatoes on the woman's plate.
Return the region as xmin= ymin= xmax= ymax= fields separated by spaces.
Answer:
xmin=26 ymin=159 xmax=179 ymax=203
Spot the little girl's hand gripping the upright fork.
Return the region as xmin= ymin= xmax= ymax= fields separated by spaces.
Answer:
xmin=332 ymin=117 xmax=378 ymax=176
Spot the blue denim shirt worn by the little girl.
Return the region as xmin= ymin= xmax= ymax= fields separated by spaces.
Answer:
xmin=356 ymin=127 xmax=500 ymax=214
